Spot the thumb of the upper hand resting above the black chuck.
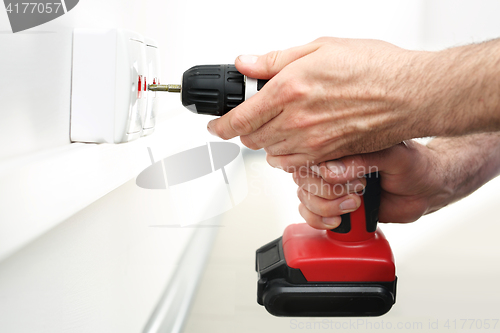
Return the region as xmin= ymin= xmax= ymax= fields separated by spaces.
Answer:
xmin=234 ymin=42 xmax=321 ymax=79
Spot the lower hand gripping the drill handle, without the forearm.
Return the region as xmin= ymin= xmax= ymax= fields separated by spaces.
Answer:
xmin=293 ymin=141 xmax=446 ymax=229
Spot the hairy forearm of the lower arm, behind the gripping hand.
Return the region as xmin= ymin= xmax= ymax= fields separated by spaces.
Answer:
xmin=427 ymin=132 xmax=500 ymax=212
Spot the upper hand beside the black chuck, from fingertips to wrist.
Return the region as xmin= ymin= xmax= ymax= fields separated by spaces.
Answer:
xmin=209 ymin=38 xmax=426 ymax=171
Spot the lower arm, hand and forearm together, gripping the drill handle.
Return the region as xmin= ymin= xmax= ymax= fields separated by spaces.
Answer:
xmin=293 ymin=133 xmax=500 ymax=229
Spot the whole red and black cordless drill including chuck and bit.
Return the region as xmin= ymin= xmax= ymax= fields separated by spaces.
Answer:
xmin=149 ymin=65 xmax=397 ymax=317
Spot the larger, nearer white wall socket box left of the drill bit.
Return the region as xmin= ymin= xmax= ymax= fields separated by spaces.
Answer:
xmin=71 ymin=29 xmax=149 ymax=143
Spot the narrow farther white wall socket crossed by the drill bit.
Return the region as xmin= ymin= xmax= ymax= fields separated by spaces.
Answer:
xmin=142 ymin=38 xmax=160 ymax=135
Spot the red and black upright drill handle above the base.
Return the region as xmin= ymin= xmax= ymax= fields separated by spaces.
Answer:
xmin=328 ymin=172 xmax=381 ymax=242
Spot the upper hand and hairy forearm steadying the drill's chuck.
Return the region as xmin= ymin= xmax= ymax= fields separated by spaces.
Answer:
xmin=208 ymin=38 xmax=500 ymax=172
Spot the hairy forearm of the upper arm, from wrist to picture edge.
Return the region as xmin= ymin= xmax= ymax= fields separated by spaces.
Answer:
xmin=411 ymin=39 xmax=500 ymax=137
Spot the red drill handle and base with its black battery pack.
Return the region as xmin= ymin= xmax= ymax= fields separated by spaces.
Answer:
xmin=255 ymin=175 xmax=397 ymax=317
